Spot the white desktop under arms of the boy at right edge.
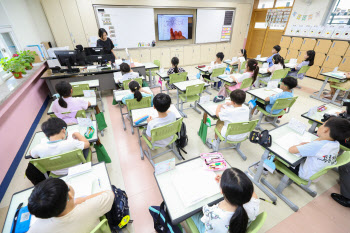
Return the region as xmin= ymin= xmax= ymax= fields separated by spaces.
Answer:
xmin=267 ymin=124 xmax=318 ymax=167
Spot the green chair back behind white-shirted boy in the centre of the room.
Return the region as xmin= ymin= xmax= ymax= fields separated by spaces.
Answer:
xmin=151 ymin=118 xmax=183 ymax=144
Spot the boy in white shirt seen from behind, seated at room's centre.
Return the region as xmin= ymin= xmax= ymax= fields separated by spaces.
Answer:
xmin=144 ymin=93 xmax=176 ymax=147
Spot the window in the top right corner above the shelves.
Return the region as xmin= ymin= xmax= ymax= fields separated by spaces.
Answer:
xmin=326 ymin=0 xmax=350 ymax=25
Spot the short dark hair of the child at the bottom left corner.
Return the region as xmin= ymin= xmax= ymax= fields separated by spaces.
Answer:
xmin=28 ymin=178 xmax=69 ymax=219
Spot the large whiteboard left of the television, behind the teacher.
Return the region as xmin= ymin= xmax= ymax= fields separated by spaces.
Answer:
xmin=95 ymin=6 xmax=156 ymax=48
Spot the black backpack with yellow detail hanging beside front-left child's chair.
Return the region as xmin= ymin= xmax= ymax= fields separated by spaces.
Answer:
xmin=106 ymin=185 xmax=132 ymax=232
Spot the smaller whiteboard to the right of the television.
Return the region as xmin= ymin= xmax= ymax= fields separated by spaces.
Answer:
xmin=196 ymin=9 xmax=234 ymax=43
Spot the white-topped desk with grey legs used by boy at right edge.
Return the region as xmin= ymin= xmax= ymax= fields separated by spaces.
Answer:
xmin=245 ymin=123 xmax=318 ymax=201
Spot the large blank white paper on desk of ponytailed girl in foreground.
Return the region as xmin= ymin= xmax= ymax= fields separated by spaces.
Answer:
xmin=171 ymin=167 xmax=220 ymax=207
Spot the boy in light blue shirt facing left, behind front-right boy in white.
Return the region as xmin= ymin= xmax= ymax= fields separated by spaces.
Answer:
xmin=251 ymin=77 xmax=298 ymax=117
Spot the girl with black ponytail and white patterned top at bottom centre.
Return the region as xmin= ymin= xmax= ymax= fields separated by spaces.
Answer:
xmin=192 ymin=168 xmax=260 ymax=233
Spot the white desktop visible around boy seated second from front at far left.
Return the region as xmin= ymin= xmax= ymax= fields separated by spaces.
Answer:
xmin=25 ymin=121 xmax=98 ymax=156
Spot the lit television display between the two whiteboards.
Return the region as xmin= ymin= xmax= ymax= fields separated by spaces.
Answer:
xmin=158 ymin=15 xmax=193 ymax=40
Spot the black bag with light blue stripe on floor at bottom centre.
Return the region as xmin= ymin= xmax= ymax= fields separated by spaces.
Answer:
xmin=149 ymin=201 xmax=182 ymax=233
